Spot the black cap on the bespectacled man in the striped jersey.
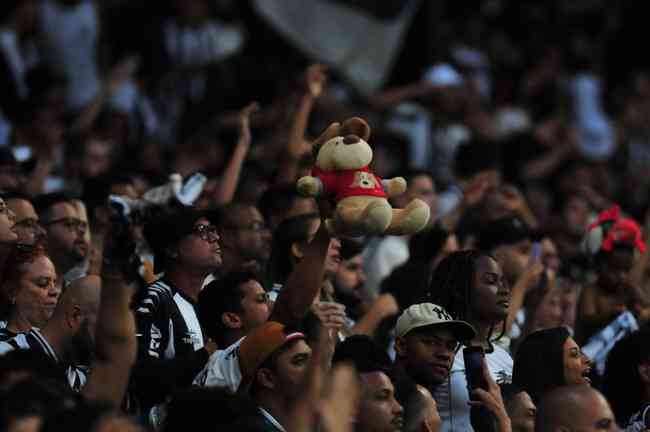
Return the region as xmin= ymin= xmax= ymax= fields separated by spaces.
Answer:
xmin=144 ymin=209 xmax=205 ymax=273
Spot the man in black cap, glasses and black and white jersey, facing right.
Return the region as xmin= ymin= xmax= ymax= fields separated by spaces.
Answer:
xmin=133 ymin=208 xmax=221 ymax=413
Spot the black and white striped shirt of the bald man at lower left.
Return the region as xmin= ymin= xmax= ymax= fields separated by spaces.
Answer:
xmin=0 ymin=328 xmax=88 ymax=392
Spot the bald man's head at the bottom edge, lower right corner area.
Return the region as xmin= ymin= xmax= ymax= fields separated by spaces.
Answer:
xmin=535 ymin=385 xmax=620 ymax=432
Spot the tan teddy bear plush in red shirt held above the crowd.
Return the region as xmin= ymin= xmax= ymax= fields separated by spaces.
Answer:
xmin=297 ymin=117 xmax=430 ymax=237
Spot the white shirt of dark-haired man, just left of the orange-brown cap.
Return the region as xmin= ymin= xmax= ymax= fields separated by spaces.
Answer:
xmin=193 ymin=338 xmax=244 ymax=392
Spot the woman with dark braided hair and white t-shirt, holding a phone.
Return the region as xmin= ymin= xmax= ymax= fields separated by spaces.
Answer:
xmin=426 ymin=250 xmax=513 ymax=432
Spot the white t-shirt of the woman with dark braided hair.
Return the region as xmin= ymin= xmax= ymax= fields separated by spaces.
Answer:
xmin=432 ymin=345 xmax=513 ymax=432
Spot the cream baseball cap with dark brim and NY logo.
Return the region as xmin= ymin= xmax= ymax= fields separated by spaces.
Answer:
xmin=395 ymin=303 xmax=476 ymax=340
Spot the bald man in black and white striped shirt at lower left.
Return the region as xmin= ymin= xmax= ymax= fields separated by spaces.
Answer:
xmin=0 ymin=276 xmax=101 ymax=391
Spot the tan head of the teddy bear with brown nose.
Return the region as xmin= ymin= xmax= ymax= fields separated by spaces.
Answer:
xmin=314 ymin=117 xmax=372 ymax=171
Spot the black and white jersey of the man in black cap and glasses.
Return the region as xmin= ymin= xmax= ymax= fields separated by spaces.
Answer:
xmin=132 ymin=279 xmax=208 ymax=407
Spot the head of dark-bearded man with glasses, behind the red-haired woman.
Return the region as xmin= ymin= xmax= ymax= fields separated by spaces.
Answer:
xmin=34 ymin=192 xmax=90 ymax=284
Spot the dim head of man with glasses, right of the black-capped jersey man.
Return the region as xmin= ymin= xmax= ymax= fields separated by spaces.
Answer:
xmin=217 ymin=203 xmax=271 ymax=275
